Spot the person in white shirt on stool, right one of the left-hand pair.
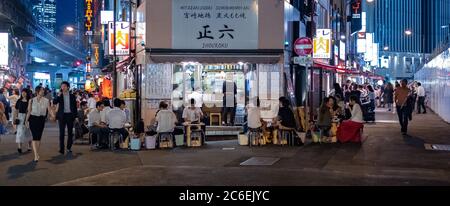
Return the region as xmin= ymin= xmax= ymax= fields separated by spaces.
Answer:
xmin=106 ymin=98 xmax=128 ymax=147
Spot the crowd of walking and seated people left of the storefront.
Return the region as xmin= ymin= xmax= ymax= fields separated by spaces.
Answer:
xmin=0 ymin=82 xmax=134 ymax=162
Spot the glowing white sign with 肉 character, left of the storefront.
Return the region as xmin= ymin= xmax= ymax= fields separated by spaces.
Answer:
xmin=108 ymin=22 xmax=130 ymax=55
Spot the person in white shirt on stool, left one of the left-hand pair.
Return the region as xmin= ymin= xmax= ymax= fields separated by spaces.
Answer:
xmin=88 ymin=102 xmax=109 ymax=147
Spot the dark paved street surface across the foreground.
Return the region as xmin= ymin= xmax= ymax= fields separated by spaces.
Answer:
xmin=0 ymin=110 xmax=450 ymax=185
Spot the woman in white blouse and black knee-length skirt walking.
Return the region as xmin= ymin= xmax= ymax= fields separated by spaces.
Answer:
xmin=25 ymin=86 xmax=54 ymax=162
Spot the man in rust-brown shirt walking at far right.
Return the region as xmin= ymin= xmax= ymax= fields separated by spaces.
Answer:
xmin=394 ymin=79 xmax=410 ymax=135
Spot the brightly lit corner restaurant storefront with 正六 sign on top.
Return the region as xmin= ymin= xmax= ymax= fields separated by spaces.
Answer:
xmin=136 ymin=0 xmax=290 ymax=125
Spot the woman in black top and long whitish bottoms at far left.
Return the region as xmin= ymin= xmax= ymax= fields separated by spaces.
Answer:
xmin=13 ymin=89 xmax=31 ymax=154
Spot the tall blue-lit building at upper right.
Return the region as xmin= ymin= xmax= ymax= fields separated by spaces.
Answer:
xmin=368 ymin=0 xmax=450 ymax=80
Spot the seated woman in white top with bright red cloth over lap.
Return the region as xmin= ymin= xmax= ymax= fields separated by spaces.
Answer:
xmin=337 ymin=95 xmax=364 ymax=143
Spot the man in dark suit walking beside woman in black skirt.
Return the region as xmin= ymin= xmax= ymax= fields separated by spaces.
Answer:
xmin=53 ymin=81 xmax=78 ymax=154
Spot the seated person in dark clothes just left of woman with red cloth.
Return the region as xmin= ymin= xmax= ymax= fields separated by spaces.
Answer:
xmin=317 ymin=97 xmax=334 ymax=142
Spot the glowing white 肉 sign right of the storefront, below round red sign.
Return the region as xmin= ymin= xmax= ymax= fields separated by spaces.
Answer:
xmin=313 ymin=29 xmax=331 ymax=59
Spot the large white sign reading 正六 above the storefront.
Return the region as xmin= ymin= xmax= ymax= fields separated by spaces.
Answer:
xmin=172 ymin=0 xmax=258 ymax=49
